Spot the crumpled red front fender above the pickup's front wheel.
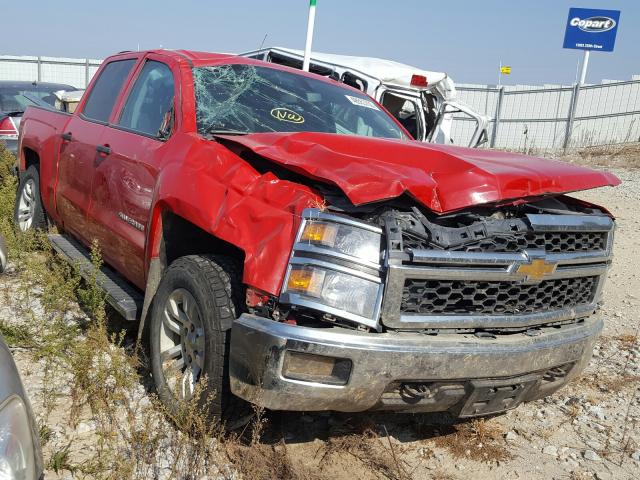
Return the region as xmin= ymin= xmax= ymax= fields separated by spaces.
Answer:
xmin=148 ymin=132 xmax=323 ymax=295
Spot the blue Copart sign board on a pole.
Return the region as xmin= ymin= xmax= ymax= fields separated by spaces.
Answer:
xmin=563 ymin=8 xmax=620 ymax=52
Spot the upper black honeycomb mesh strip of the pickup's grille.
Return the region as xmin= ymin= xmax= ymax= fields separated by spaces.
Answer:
xmin=402 ymin=232 xmax=607 ymax=253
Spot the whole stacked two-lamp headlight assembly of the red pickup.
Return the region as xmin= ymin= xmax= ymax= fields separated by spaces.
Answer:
xmin=280 ymin=209 xmax=383 ymax=328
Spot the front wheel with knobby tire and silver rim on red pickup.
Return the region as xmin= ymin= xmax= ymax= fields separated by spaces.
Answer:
xmin=149 ymin=255 xmax=241 ymax=418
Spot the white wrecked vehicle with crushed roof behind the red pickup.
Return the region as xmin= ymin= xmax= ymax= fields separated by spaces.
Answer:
xmin=242 ymin=47 xmax=489 ymax=147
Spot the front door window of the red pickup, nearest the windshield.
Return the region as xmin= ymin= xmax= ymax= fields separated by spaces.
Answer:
xmin=118 ymin=60 xmax=173 ymax=137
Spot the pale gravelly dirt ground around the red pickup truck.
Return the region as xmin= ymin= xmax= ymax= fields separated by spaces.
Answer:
xmin=0 ymin=151 xmax=640 ymax=480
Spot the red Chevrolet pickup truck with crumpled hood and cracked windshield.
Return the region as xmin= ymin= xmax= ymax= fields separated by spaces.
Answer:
xmin=16 ymin=50 xmax=619 ymax=417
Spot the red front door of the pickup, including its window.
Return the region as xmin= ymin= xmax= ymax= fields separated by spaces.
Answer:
xmin=90 ymin=58 xmax=176 ymax=288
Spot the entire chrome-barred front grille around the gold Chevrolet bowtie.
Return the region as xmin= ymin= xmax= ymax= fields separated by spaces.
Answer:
xmin=381 ymin=214 xmax=614 ymax=330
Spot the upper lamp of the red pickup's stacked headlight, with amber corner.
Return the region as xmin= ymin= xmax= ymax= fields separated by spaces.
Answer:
xmin=298 ymin=219 xmax=381 ymax=265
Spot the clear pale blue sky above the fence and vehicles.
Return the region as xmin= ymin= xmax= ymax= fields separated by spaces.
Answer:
xmin=0 ymin=0 xmax=640 ymax=85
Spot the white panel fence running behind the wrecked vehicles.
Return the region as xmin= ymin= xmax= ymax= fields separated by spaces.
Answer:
xmin=0 ymin=55 xmax=640 ymax=152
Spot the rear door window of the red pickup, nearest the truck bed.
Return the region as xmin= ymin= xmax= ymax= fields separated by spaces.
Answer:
xmin=82 ymin=59 xmax=136 ymax=122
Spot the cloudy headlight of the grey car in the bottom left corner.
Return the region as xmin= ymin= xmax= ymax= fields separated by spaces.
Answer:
xmin=0 ymin=397 xmax=36 ymax=480
